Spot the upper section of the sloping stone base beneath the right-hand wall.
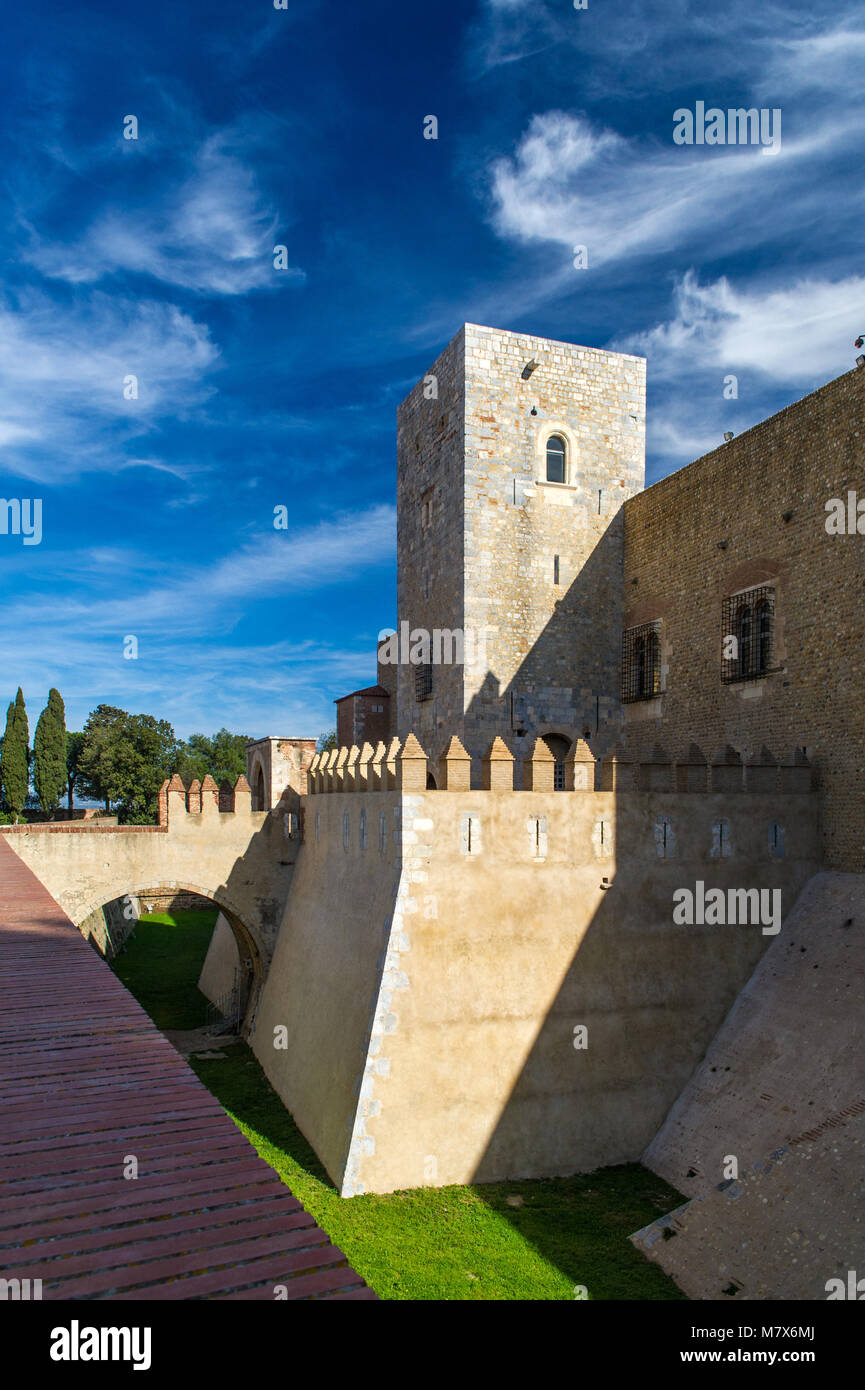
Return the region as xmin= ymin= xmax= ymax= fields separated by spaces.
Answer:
xmin=644 ymin=873 xmax=865 ymax=1197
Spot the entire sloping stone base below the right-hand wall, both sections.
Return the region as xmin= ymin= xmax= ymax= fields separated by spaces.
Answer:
xmin=631 ymin=873 xmax=865 ymax=1302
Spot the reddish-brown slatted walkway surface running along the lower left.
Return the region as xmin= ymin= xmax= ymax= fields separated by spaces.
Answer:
xmin=0 ymin=835 xmax=374 ymax=1300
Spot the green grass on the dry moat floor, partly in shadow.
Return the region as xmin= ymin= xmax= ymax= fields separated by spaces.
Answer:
xmin=115 ymin=913 xmax=684 ymax=1300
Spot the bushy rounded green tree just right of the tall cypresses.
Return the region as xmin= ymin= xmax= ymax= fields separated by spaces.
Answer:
xmin=78 ymin=705 xmax=181 ymax=826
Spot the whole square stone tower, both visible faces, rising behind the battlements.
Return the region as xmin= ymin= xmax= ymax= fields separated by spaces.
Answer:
xmin=398 ymin=324 xmax=645 ymax=785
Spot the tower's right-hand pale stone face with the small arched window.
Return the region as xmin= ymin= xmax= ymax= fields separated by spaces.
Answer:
xmin=464 ymin=324 xmax=645 ymax=758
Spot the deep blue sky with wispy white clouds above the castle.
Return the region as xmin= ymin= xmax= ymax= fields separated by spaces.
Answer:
xmin=0 ymin=0 xmax=865 ymax=737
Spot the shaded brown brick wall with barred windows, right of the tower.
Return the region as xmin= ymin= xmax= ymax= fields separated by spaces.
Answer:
xmin=624 ymin=368 xmax=865 ymax=872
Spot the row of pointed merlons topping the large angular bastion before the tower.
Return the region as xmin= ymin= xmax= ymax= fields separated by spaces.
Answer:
xmin=307 ymin=734 xmax=814 ymax=795
